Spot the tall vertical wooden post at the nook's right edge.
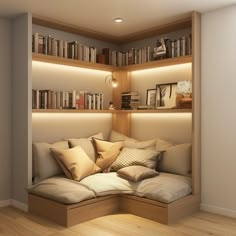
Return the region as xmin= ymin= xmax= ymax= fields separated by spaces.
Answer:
xmin=192 ymin=12 xmax=201 ymax=194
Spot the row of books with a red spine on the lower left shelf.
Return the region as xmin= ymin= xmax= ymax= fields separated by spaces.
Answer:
xmin=32 ymin=89 xmax=103 ymax=110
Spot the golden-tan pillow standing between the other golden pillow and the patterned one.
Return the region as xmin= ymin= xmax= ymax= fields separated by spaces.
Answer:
xmin=93 ymin=138 xmax=123 ymax=171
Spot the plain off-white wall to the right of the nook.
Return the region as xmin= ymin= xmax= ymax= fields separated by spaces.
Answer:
xmin=202 ymin=6 xmax=236 ymax=217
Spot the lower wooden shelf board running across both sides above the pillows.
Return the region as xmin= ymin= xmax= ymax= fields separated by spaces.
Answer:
xmin=32 ymin=109 xmax=192 ymax=113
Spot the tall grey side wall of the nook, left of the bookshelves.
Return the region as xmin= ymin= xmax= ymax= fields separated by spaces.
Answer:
xmin=12 ymin=14 xmax=32 ymax=203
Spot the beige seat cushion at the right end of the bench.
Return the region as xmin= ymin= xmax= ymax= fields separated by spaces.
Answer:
xmin=134 ymin=172 xmax=192 ymax=203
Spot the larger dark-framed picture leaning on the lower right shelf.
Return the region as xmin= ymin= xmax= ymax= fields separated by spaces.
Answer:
xmin=155 ymin=83 xmax=177 ymax=109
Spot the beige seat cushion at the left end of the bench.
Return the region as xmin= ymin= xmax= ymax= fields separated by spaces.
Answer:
xmin=27 ymin=176 xmax=96 ymax=204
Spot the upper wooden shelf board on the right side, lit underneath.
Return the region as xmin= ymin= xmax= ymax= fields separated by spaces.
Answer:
xmin=119 ymin=55 xmax=192 ymax=71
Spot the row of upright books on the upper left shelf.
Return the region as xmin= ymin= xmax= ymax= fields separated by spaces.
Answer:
xmin=32 ymin=33 xmax=97 ymax=63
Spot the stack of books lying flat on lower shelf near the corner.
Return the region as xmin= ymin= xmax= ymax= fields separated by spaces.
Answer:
xmin=121 ymin=91 xmax=140 ymax=110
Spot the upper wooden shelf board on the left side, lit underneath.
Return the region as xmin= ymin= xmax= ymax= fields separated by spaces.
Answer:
xmin=32 ymin=53 xmax=117 ymax=72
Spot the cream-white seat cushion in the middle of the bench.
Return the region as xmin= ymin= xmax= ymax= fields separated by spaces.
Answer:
xmin=80 ymin=172 xmax=137 ymax=196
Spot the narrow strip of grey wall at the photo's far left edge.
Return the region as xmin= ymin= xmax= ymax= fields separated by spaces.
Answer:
xmin=0 ymin=19 xmax=12 ymax=201
